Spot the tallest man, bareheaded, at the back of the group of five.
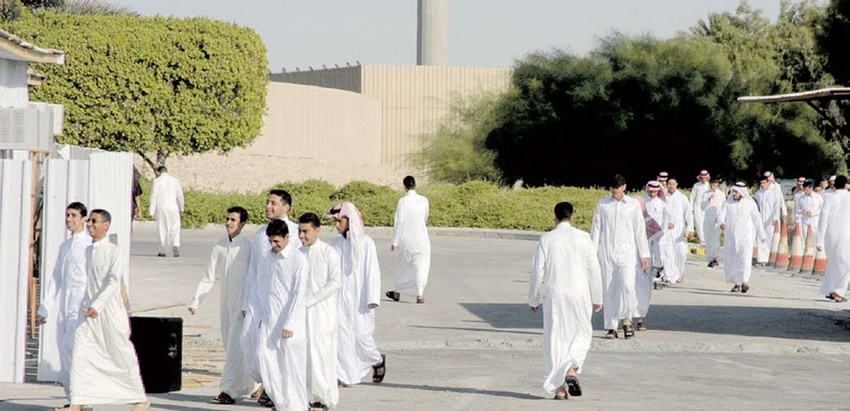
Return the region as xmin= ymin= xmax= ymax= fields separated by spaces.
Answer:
xmin=241 ymin=189 xmax=301 ymax=405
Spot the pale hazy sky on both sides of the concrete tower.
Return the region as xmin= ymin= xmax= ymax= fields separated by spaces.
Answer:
xmin=106 ymin=0 xmax=780 ymax=72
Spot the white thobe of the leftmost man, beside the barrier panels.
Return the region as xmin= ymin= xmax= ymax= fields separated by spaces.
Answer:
xmin=38 ymin=229 xmax=91 ymax=397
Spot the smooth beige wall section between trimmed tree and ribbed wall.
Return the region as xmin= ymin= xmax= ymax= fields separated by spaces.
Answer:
xmin=246 ymin=82 xmax=382 ymax=164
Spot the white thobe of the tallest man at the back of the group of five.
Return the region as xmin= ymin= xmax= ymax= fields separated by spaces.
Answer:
xmin=241 ymin=216 xmax=301 ymax=382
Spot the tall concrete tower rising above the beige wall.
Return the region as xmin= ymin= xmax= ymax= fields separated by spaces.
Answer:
xmin=416 ymin=0 xmax=449 ymax=66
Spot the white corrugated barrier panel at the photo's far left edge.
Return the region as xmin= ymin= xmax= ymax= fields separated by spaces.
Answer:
xmin=0 ymin=160 xmax=32 ymax=383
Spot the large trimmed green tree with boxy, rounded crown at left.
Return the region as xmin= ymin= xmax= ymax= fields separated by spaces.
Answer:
xmin=7 ymin=11 xmax=268 ymax=172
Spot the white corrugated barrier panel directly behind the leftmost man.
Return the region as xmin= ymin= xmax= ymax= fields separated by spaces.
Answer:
xmin=37 ymin=160 xmax=89 ymax=381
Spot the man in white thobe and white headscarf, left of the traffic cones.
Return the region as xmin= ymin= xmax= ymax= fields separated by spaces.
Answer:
xmin=717 ymin=182 xmax=767 ymax=293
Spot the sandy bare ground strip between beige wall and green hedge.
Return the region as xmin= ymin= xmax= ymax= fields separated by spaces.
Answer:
xmin=135 ymin=150 xmax=426 ymax=193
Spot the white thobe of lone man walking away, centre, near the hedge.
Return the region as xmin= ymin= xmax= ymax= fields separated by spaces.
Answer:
xmin=392 ymin=190 xmax=431 ymax=296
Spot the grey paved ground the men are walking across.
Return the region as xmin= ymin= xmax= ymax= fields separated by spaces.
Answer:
xmin=0 ymin=223 xmax=850 ymax=411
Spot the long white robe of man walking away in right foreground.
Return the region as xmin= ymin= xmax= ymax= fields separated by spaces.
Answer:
xmin=528 ymin=222 xmax=602 ymax=393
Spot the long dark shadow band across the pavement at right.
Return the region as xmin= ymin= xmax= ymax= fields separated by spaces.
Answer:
xmin=461 ymin=303 xmax=850 ymax=342
